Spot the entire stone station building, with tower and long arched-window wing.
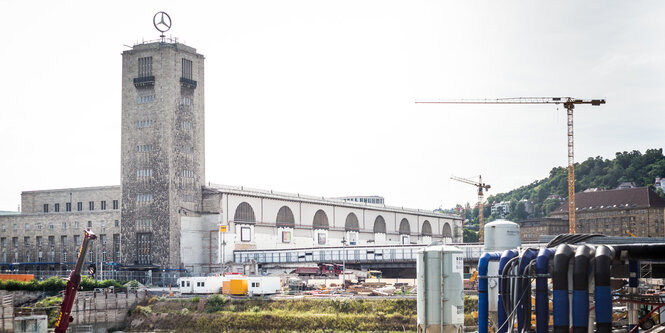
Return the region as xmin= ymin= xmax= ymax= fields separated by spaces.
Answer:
xmin=0 ymin=39 xmax=462 ymax=273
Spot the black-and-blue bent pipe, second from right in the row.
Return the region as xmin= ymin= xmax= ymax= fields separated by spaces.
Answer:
xmin=573 ymin=245 xmax=594 ymax=333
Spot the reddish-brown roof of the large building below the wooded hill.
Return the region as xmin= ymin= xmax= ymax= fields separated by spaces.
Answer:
xmin=552 ymin=187 xmax=665 ymax=214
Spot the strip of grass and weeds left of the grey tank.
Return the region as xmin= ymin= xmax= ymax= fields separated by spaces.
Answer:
xmin=131 ymin=295 xmax=416 ymax=332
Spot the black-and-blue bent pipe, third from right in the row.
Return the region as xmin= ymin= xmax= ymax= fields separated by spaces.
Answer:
xmin=552 ymin=244 xmax=573 ymax=333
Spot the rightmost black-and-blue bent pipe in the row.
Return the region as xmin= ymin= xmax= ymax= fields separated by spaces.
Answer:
xmin=592 ymin=245 xmax=614 ymax=333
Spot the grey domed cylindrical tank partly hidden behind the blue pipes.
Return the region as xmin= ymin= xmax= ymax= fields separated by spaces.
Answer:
xmin=485 ymin=220 xmax=522 ymax=312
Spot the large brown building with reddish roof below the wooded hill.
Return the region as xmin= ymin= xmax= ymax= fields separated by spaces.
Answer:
xmin=550 ymin=187 xmax=665 ymax=237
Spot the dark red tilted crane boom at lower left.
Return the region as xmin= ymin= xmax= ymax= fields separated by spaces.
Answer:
xmin=55 ymin=229 xmax=97 ymax=333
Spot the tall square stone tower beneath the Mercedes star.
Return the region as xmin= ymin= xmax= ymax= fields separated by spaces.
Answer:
xmin=121 ymin=41 xmax=205 ymax=268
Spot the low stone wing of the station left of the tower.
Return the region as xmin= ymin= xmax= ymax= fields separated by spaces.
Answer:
xmin=0 ymin=186 xmax=121 ymax=270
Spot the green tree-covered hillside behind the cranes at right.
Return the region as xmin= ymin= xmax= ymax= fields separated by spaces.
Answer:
xmin=458 ymin=148 xmax=665 ymax=238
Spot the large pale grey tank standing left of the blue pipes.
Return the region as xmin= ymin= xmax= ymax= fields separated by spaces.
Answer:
xmin=416 ymin=241 xmax=464 ymax=333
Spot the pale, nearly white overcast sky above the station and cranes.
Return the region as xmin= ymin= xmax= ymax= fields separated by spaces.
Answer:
xmin=0 ymin=0 xmax=665 ymax=210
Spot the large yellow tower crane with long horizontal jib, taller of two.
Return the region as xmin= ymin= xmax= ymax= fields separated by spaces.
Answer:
xmin=416 ymin=97 xmax=605 ymax=234
